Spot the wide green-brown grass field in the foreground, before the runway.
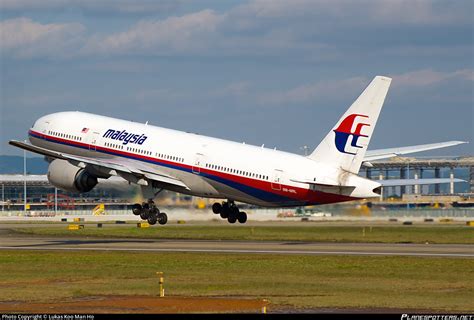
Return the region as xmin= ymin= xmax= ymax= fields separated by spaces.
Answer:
xmin=0 ymin=250 xmax=474 ymax=312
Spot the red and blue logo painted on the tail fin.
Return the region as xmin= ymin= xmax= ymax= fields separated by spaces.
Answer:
xmin=334 ymin=114 xmax=370 ymax=155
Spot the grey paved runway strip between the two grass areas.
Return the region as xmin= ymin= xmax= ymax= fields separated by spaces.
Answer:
xmin=0 ymin=235 xmax=474 ymax=258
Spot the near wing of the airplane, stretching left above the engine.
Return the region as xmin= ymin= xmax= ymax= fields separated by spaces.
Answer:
xmin=9 ymin=140 xmax=189 ymax=190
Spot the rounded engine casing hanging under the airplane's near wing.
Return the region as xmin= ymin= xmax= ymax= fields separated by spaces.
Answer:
xmin=48 ymin=159 xmax=97 ymax=193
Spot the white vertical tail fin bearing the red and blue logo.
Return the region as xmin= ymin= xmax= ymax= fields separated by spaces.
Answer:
xmin=308 ymin=76 xmax=392 ymax=174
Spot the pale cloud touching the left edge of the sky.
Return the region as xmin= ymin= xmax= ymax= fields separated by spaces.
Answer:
xmin=0 ymin=17 xmax=85 ymax=58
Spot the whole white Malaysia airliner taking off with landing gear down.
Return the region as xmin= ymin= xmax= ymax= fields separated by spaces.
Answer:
xmin=9 ymin=76 xmax=465 ymax=225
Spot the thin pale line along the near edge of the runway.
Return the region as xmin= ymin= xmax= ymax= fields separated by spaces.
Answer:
xmin=0 ymin=246 xmax=474 ymax=258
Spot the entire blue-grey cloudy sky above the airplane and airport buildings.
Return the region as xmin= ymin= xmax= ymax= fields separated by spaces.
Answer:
xmin=0 ymin=0 xmax=474 ymax=156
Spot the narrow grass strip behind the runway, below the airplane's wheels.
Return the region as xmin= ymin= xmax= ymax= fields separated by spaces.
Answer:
xmin=15 ymin=224 xmax=474 ymax=244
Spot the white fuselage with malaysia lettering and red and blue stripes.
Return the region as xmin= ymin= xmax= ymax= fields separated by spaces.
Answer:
xmin=29 ymin=112 xmax=379 ymax=207
